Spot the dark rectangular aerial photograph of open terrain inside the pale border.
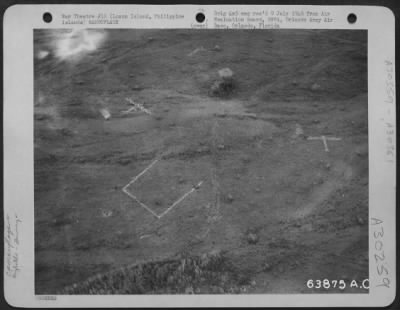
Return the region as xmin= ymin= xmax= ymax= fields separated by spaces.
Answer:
xmin=34 ymin=29 xmax=368 ymax=294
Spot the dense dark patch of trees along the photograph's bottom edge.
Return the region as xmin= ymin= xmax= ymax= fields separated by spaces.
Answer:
xmin=59 ymin=252 xmax=247 ymax=294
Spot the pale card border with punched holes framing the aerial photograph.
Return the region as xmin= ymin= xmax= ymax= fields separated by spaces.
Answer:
xmin=3 ymin=5 xmax=396 ymax=308
